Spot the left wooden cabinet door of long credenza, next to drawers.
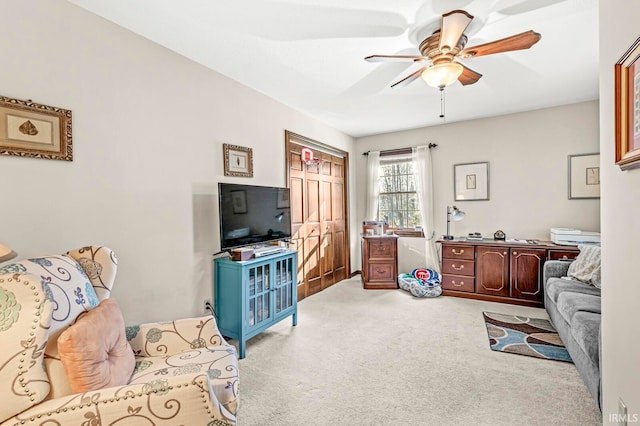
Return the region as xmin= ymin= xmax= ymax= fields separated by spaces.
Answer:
xmin=476 ymin=247 xmax=509 ymax=296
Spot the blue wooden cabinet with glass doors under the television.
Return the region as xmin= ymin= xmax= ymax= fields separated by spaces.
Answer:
xmin=213 ymin=250 xmax=298 ymax=359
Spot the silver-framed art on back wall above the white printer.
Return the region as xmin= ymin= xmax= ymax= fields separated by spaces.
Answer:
xmin=568 ymin=153 xmax=600 ymax=200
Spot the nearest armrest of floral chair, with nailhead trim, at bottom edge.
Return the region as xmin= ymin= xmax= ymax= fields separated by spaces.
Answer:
xmin=1 ymin=374 xmax=236 ymax=426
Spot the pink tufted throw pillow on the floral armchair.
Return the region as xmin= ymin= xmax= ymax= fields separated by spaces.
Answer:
xmin=58 ymin=299 xmax=135 ymax=393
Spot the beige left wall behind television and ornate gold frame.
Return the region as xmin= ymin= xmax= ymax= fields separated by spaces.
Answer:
xmin=0 ymin=0 xmax=358 ymax=324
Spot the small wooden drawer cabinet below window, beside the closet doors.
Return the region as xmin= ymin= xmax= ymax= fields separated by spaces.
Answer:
xmin=362 ymin=235 xmax=398 ymax=289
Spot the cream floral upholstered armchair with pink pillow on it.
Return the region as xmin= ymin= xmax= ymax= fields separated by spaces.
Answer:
xmin=0 ymin=246 xmax=238 ymax=426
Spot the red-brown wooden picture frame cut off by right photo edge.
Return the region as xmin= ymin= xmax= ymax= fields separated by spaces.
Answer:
xmin=615 ymin=38 xmax=640 ymax=170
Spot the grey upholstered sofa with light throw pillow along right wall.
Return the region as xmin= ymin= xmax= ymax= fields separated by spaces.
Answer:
xmin=543 ymin=246 xmax=602 ymax=410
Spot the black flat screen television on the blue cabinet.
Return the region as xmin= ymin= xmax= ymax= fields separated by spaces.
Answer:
xmin=218 ymin=182 xmax=291 ymax=251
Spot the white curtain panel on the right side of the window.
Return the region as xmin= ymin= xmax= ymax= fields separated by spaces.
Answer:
xmin=411 ymin=146 xmax=440 ymax=272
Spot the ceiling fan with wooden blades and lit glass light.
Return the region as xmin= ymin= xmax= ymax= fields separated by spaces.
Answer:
xmin=364 ymin=10 xmax=541 ymax=90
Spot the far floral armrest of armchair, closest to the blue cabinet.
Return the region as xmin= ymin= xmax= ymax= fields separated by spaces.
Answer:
xmin=126 ymin=315 xmax=231 ymax=357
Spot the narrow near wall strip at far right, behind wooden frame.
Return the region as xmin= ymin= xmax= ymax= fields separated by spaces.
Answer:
xmin=600 ymin=0 xmax=640 ymax=424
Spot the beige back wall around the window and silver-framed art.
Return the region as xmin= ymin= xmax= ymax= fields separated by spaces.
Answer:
xmin=356 ymin=101 xmax=600 ymax=266
